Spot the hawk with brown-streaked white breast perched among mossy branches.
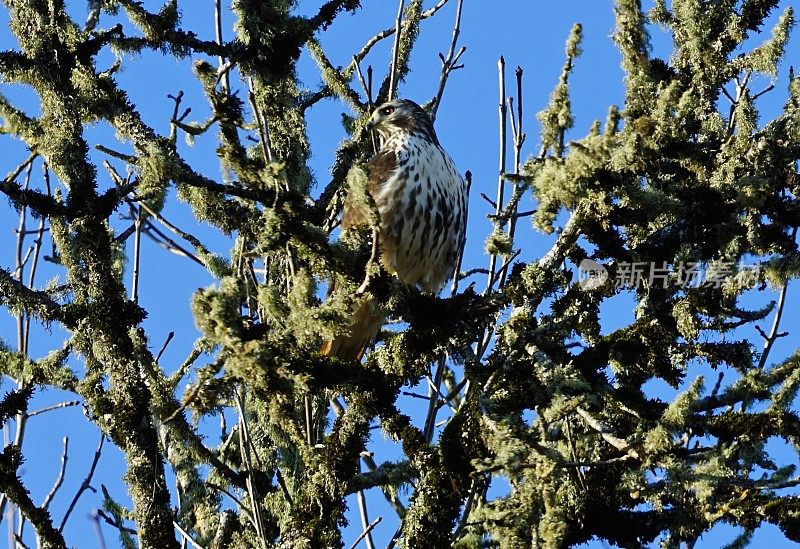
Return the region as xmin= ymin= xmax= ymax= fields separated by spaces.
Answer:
xmin=321 ymin=99 xmax=467 ymax=360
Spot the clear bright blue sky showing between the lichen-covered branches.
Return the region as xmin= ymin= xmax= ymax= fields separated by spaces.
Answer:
xmin=0 ymin=0 xmax=800 ymax=547
